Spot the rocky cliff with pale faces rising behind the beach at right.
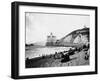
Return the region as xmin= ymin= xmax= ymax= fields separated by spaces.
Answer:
xmin=57 ymin=28 xmax=89 ymax=45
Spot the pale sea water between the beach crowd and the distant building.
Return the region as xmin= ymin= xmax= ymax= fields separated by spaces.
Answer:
xmin=25 ymin=46 xmax=70 ymax=58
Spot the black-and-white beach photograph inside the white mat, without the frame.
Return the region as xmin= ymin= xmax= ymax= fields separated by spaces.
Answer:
xmin=25 ymin=12 xmax=90 ymax=68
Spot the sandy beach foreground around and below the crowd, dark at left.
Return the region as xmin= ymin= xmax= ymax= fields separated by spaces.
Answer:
xmin=26 ymin=50 xmax=89 ymax=68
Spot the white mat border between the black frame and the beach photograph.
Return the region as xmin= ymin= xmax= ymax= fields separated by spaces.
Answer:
xmin=19 ymin=6 xmax=95 ymax=76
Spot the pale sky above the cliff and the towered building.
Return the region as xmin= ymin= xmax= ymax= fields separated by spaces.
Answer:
xmin=25 ymin=12 xmax=90 ymax=43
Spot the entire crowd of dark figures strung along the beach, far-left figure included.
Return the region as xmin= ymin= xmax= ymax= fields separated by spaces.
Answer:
xmin=26 ymin=44 xmax=90 ymax=63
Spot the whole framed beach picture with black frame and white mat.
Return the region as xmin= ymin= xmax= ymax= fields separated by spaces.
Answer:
xmin=11 ymin=2 xmax=97 ymax=79
